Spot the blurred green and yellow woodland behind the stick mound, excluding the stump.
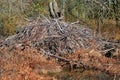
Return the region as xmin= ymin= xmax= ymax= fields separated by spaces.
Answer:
xmin=0 ymin=0 xmax=120 ymax=40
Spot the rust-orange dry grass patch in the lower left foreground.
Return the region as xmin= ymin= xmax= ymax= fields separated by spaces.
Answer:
xmin=0 ymin=46 xmax=61 ymax=80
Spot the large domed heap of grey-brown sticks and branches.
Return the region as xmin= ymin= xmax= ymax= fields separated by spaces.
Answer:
xmin=3 ymin=19 xmax=119 ymax=54
